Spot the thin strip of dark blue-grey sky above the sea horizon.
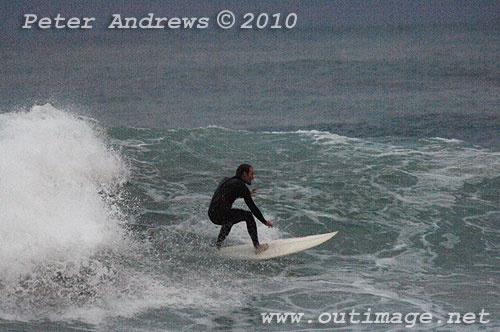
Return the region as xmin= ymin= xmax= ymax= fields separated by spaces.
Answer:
xmin=0 ymin=0 xmax=500 ymax=36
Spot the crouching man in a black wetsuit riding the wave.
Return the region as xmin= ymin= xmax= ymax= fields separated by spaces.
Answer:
xmin=208 ymin=164 xmax=273 ymax=254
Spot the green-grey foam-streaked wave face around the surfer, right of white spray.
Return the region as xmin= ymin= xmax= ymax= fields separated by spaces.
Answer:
xmin=103 ymin=122 xmax=500 ymax=331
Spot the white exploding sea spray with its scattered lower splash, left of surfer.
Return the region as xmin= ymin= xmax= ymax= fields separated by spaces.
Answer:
xmin=0 ymin=105 xmax=166 ymax=320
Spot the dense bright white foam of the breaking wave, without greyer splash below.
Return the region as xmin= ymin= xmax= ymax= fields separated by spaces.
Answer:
xmin=0 ymin=105 xmax=127 ymax=279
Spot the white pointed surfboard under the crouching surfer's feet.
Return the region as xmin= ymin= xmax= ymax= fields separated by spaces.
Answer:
xmin=218 ymin=232 xmax=338 ymax=259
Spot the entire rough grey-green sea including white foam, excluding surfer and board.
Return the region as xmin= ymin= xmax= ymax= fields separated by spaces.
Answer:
xmin=0 ymin=22 xmax=500 ymax=331
